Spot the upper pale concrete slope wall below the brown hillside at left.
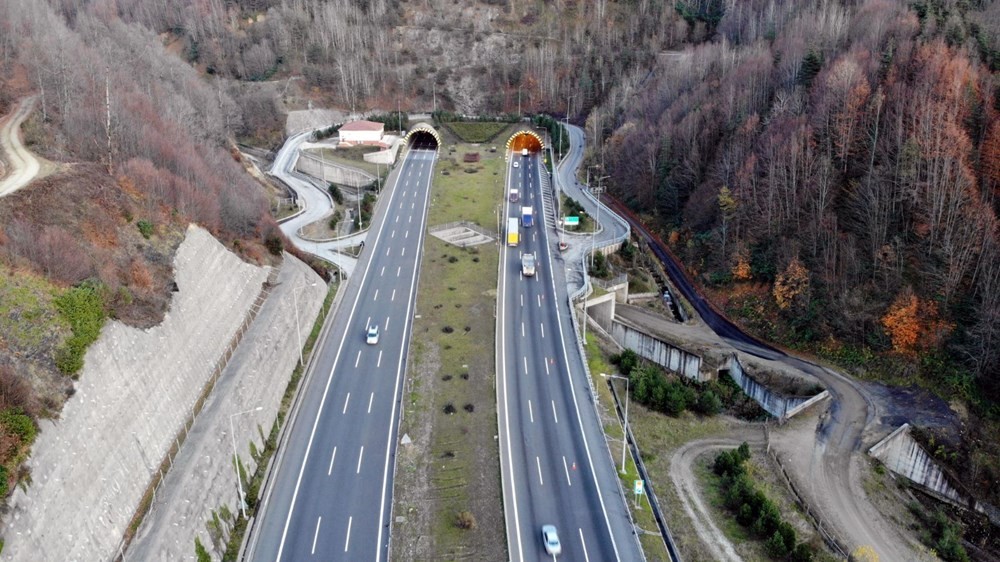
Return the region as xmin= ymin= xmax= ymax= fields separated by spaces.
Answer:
xmin=2 ymin=226 xmax=268 ymax=561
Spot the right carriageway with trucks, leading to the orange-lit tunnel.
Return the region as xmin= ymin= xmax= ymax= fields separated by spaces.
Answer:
xmin=497 ymin=150 xmax=643 ymax=562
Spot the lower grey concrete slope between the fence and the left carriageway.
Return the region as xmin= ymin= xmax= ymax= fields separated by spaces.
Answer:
xmin=125 ymin=254 xmax=326 ymax=561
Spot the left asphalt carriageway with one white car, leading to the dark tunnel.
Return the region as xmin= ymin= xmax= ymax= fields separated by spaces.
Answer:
xmin=245 ymin=143 xmax=437 ymax=562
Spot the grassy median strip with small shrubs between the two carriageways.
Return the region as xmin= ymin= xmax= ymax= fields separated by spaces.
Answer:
xmin=392 ymin=144 xmax=506 ymax=560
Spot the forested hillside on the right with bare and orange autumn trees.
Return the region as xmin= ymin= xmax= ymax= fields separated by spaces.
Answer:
xmin=589 ymin=0 xmax=1000 ymax=498
